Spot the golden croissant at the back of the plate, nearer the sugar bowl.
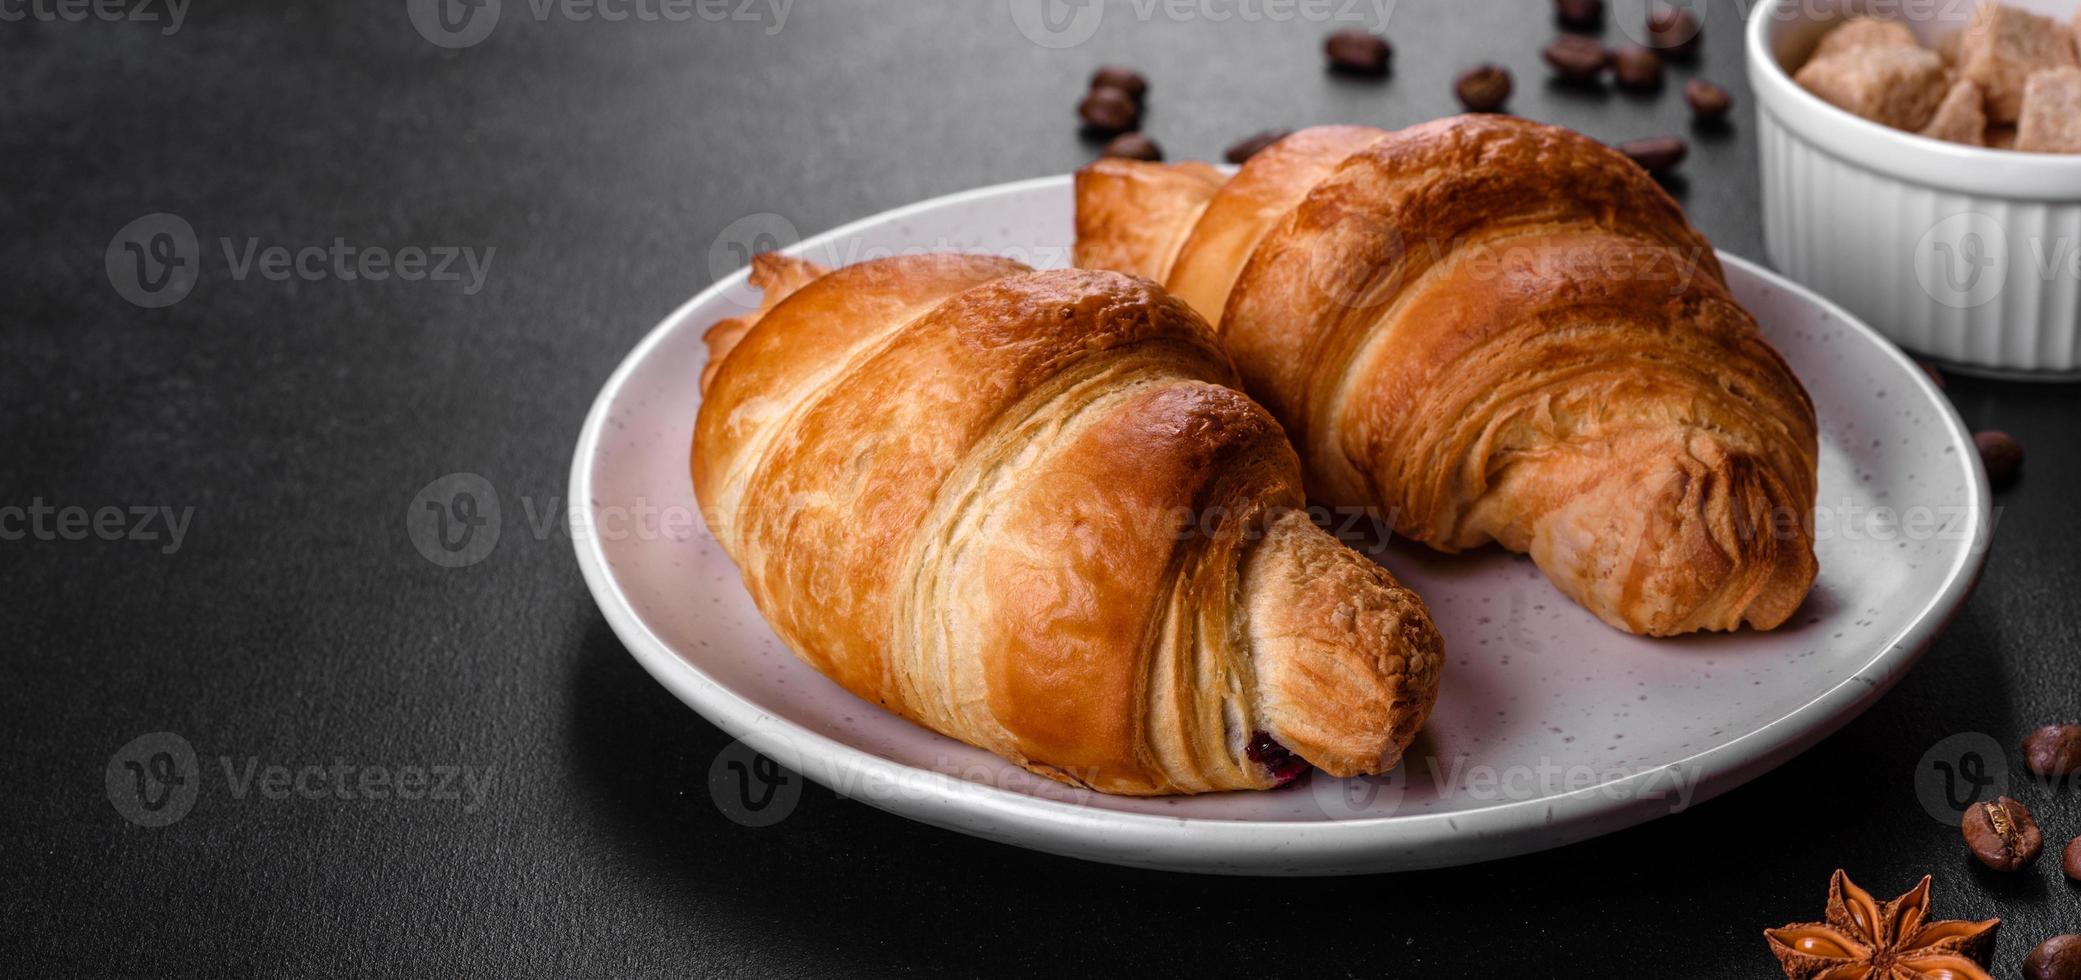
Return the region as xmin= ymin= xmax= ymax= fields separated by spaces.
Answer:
xmin=1076 ymin=114 xmax=1817 ymax=637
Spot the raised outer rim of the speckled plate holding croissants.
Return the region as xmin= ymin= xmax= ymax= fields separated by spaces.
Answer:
xmin=570 ymin=175 xmax=1992 ymax=876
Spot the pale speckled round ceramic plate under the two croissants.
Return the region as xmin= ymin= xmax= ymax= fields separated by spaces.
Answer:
xmin=570 ymin=177 xmax=1987 ymax=874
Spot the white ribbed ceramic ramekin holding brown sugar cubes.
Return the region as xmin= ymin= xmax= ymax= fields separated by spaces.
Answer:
xmin=1748 ymin=0 xmax=2081 ymax=379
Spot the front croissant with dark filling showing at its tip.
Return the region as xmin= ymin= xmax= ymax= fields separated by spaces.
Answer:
xmin=693 ymin=254 xmax=1442 ymax=795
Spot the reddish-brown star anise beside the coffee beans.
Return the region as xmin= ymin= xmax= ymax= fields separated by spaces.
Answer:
xmin=1763 ymin=872 xmax=2002 ymax=980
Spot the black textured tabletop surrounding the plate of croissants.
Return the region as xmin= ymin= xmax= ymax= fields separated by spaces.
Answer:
xmin=0 ymin=0 xmax=2081 ymax=976
